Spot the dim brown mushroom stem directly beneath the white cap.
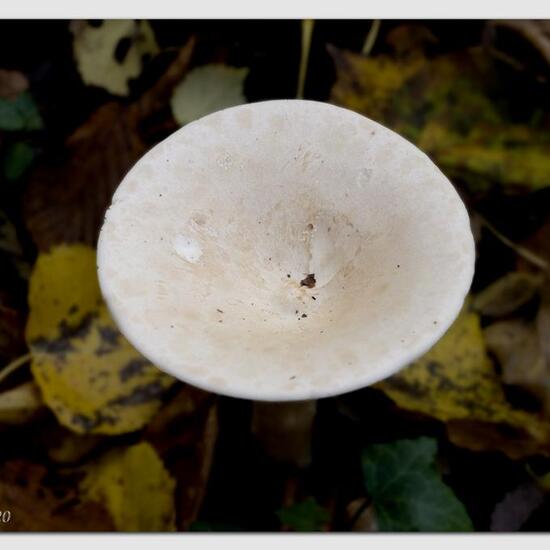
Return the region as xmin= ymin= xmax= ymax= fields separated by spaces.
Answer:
xmin=252 ymin=399 xmax=317 ymax=468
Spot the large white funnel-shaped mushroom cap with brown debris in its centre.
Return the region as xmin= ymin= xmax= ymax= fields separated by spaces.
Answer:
xmin=98 ymin=100 xmax=475 ymax=400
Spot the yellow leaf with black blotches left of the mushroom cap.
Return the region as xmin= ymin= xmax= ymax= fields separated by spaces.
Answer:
xmin=26 ymin=245 xmax=174 ymax=434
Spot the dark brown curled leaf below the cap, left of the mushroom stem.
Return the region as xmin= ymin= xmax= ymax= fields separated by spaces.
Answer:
xmin=145 ymin=386 xmax=218 ymax=531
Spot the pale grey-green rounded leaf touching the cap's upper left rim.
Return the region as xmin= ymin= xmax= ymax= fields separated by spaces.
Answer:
xmin=170 ymin=64 xmax=248 ymax=124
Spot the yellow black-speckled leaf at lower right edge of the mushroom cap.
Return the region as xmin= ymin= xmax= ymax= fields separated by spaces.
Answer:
xmin=377 ymin=306 xmax=550 ymax=460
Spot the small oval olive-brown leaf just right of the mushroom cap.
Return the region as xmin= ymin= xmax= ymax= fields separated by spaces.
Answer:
xmin=472 ymin=271 xmax=542 ymax=317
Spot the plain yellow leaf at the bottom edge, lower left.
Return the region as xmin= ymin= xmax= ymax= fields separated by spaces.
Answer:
xmin=81 ymin=443 xmax=175 ymax=531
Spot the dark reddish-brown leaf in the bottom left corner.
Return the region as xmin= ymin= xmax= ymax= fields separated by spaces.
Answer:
xmin=0 ymin=460 xmax=114 ymax=532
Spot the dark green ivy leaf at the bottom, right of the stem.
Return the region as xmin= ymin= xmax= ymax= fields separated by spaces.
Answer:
xmin=363 ymin=437 xmax=473 ymax=532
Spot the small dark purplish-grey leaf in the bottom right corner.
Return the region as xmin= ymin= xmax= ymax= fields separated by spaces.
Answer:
xmin=491 ymin=482 xmax=544 ymax=532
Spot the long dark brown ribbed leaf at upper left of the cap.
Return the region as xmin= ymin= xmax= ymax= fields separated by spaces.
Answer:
xmin=24 ymin=39 xmax=194 ymax=251
